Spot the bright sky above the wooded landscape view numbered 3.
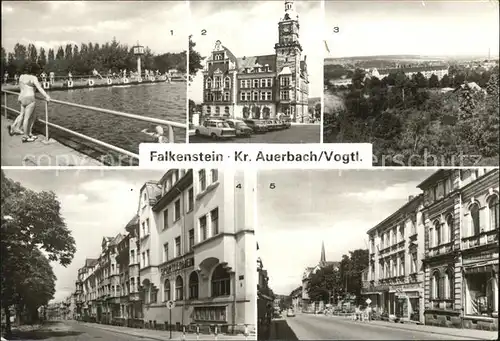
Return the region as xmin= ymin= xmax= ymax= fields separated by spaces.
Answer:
xmin=325 ymin=0 xmax=499 ymax=58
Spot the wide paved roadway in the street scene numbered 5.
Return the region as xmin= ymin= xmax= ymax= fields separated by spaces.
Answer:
xmin=272 ymin=314 xmax=497 ymax=340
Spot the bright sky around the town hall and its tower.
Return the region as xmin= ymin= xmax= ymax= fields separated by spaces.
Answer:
xmin=189 ymin=0 xmax=324 ymax=103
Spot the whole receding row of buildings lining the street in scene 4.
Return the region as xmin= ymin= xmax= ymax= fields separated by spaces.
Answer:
xmin=76 ymin=169 xmax=257 ymax=333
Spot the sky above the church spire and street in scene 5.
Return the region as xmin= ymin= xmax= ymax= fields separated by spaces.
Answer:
xmin=256 ymin=169 xmax=434 ymax=295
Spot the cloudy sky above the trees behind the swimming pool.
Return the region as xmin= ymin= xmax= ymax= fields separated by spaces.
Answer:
xmin=2 ymin=1 xmax=189 ymax=54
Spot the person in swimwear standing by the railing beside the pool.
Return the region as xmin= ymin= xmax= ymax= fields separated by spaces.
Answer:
xmin=9 ymin=63 xmax=50 ymax=142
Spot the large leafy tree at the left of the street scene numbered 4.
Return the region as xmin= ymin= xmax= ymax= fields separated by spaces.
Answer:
xmin=0 ymin=171 xmax=76 ymax=332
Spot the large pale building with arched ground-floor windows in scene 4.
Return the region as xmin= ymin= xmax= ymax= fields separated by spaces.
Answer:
xmin=137 ymin=169 xmax=257 ymax=333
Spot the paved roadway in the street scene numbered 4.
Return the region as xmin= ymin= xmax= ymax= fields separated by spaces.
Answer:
xmin=9 ymin=321 xmax=256 ymax=341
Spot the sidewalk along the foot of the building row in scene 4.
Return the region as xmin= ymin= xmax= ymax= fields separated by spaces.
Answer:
xmin=78 ymin=322 xmax=257 ymax=341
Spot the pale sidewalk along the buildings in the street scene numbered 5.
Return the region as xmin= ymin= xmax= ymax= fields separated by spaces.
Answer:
xmin=317 ymin=315 xmax=498 ymax=340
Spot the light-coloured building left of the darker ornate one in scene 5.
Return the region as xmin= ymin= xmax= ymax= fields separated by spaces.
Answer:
xmin=362 ymin=195 xmax=424 ymax=323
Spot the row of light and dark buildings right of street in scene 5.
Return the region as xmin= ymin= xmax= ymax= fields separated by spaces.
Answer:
xmin=363 ymin=169 xmax=500 ymax=330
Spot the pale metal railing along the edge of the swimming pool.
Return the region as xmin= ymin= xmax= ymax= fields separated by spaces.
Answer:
xmin=2 ymin=89 xmax=187 ymax=160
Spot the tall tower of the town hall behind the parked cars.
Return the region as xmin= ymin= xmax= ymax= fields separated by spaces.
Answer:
xmin=274 ymin=0 xmax=302 ymax=121
